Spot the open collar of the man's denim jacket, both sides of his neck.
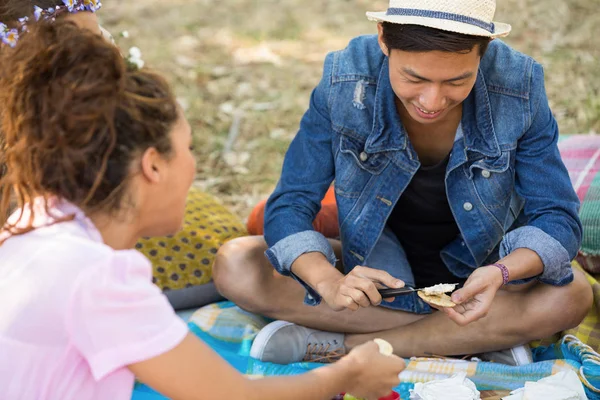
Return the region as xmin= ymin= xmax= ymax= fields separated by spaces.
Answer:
xmin=365 ymin=57 xmax=501 ymax=157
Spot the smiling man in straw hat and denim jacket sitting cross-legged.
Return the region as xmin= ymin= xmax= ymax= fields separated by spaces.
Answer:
xmin=214 ymin=0 xmax=592 ymax=364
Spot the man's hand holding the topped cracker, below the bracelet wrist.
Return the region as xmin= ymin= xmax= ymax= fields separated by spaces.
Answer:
xmin=442 ymin=266 xmax=503 ymax=326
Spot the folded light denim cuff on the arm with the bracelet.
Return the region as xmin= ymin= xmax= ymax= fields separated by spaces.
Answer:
xmin=500 ymin=226 xmax=573 ymax=286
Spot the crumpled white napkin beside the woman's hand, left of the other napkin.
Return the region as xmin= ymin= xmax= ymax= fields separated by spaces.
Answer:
xmin=410 ymin=372 xmax=480 ymax=400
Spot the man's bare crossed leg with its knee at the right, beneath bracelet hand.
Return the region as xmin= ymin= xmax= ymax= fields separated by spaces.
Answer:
xmin=345 ymin=270 xmax=592 ymax=357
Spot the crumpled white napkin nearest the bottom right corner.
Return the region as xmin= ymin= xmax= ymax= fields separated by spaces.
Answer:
xmin=503 ymin=371 xmax=587 ymax=400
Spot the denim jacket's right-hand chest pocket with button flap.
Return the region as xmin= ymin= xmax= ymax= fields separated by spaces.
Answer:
xmin=467 ymin=151 xmax=515 ymax=210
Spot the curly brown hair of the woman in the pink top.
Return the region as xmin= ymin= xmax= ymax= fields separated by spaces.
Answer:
xmin=0 ymin=20 xmax=178 ymax=238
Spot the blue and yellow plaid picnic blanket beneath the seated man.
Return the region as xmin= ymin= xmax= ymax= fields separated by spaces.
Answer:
xmin=133 ymin=302 xmax=600 ymax=400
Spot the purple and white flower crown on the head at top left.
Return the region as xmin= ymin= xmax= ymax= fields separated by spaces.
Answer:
xmin=0 ymin=0 xmax=102 ymax=47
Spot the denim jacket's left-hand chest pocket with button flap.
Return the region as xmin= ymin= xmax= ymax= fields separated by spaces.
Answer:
xmin=335 ymin=132 xmax=390 ymax=198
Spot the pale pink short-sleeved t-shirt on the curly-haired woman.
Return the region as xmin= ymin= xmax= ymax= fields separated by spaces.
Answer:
xmin=0 ymin=202 xmax=188 ymax=400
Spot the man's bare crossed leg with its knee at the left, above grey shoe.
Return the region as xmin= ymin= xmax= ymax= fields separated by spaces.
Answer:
xmin=213 ymin=236 xmax=423 ymax=333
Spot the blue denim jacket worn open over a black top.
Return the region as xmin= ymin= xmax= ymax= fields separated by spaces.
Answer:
xmin=265 ymin=36 xmax=582 ymax=305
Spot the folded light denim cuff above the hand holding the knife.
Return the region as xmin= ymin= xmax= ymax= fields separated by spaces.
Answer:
xmin=265 ymin=231 xmax=336 ymax=306
